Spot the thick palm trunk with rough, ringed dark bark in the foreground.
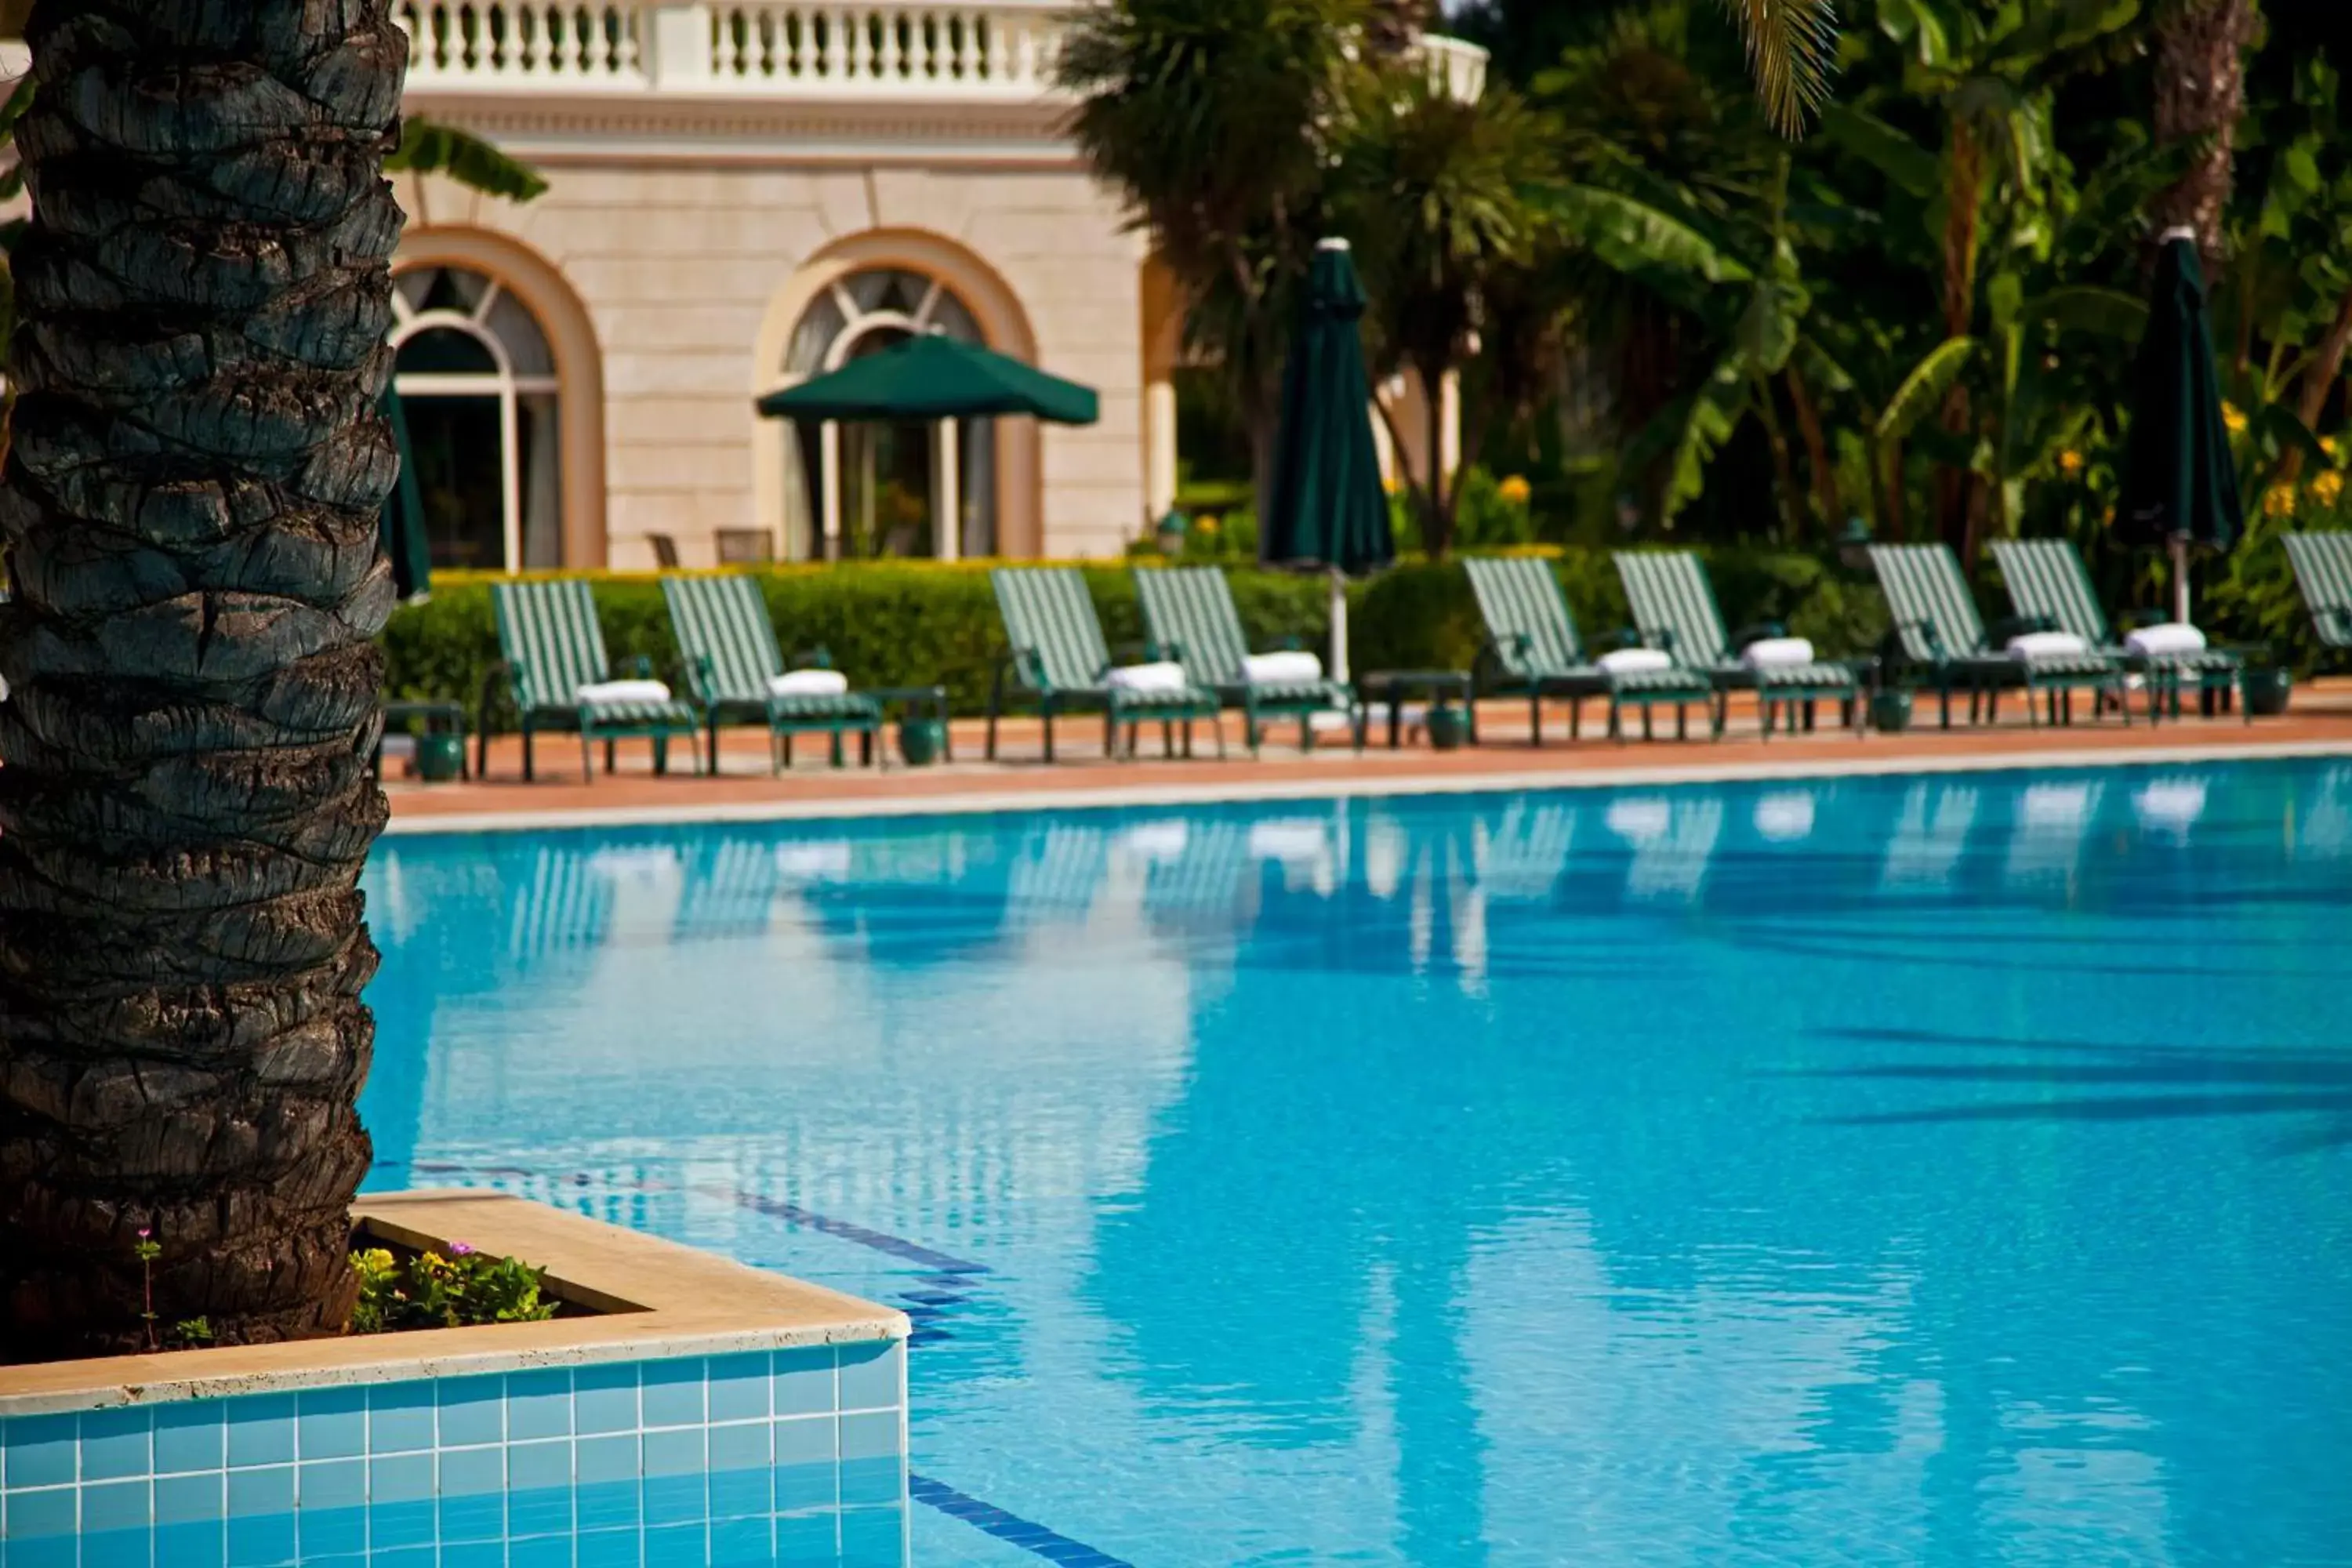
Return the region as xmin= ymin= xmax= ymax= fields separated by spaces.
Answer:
xmin=0 ymin=0 xmax=407 ymax=1361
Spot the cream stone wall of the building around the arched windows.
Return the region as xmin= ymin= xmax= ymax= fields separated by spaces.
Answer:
xmin=395 ymin=158 xmax=1145 ymax=567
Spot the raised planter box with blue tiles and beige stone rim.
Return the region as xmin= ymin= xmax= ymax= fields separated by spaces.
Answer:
xmin=0 ymin=1192 xmax=908 ymax=1568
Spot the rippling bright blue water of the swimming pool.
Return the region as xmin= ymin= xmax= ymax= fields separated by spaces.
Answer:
xmin=365 ymin=762 xmax=2352 ymax=1568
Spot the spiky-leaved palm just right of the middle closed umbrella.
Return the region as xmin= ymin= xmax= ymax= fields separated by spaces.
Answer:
xmin=1331 ymin=66 xmax=1552 ymax=557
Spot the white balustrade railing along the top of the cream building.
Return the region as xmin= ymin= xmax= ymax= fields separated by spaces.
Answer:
xmin=393 ymin=0 xmax=1486 ymax=101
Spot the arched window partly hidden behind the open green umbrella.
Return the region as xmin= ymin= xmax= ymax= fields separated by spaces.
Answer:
xmin=781 ymin=268 xmax=997 ymax=560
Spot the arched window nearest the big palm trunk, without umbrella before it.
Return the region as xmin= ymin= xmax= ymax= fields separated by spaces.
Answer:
xmin=393 ymin=266 xmax=564 ymax=572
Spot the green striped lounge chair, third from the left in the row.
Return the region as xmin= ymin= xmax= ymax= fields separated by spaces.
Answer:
xmin=988 ymin=567 xmax=1225 ymax=762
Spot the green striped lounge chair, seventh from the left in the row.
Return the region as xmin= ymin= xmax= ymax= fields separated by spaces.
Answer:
xmin=1870 ymin=543 xmax=2131 ymax=729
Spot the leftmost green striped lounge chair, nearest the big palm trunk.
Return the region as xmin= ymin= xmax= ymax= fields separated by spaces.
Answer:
xmin=473 ymin=579 xmax=699 ymax=781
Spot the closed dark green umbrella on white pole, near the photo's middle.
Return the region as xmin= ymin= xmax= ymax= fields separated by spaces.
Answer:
xmin=1258 ymin=240 xmax=1397 ymax=680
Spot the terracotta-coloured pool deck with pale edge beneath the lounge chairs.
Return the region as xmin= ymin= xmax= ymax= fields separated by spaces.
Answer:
xmin=386 ymin=680 xmax=2352 ymax=832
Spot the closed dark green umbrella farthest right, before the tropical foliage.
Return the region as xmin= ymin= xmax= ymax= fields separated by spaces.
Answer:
xmin=2114 ymin=228 xmax=2246 ymax=621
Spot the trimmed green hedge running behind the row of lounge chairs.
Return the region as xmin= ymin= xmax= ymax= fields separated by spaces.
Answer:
xmin=383 ymin=548 xmax=1886 ymax=713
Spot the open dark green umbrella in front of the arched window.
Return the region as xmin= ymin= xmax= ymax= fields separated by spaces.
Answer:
xmin=757 ymin=332 xmax=1098 ymax=426
